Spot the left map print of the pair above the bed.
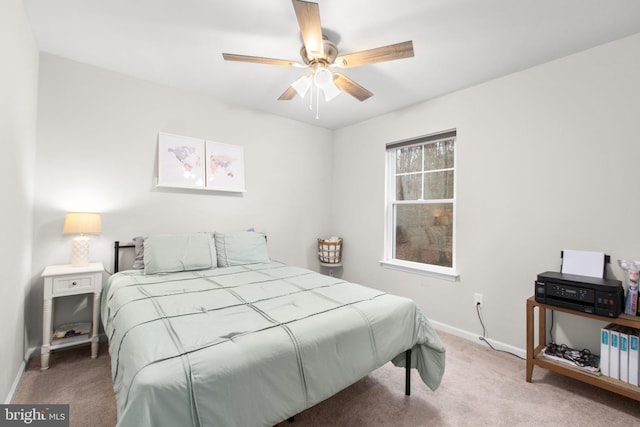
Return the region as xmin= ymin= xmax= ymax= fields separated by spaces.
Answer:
xmin=158 ymin=132 xmax=205 ymax=188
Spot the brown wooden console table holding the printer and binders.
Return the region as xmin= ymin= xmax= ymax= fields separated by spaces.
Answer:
xmin=526 ymin=297 xmax=640 ymax=401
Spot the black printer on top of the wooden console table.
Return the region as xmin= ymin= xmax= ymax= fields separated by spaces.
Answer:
xmin=535 ymin=271 xmax=624 ymax=317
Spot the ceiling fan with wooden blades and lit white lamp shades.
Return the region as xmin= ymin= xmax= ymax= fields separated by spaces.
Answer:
xmin=222 ymin=0 xmax=413 ymax=106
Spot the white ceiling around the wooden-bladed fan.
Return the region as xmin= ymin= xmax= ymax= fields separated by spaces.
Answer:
xmin=24 ymin=0 xmax=640 ymax=129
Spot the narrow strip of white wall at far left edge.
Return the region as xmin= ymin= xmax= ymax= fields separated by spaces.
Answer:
xmin=0 ymin=0 xmax=38 ymax=402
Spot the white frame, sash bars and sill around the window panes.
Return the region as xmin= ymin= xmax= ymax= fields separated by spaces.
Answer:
xmin=380 ymin=129 xmax=459 ymax=281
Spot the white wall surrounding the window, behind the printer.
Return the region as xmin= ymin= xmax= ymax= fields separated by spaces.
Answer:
xmin=333 ymin=35 xmax=640 ymax=349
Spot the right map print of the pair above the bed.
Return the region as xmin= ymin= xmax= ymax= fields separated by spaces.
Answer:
xmin=205 ymin=141 xmax=245 ymax=192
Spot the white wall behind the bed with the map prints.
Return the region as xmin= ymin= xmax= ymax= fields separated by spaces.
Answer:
xmin=29 ymin=54 xmax=333 ymax=345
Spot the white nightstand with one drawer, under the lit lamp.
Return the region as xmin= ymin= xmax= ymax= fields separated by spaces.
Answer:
xmin=41 ymin=262 xmax=104 ymax=370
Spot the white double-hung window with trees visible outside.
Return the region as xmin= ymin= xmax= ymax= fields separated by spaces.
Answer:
xmin=383 ymin=130 xmax=457 ymax=279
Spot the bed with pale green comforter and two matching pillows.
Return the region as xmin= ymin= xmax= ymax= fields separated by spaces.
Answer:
xmin=101 ymin=232 xmax=445 ymax=427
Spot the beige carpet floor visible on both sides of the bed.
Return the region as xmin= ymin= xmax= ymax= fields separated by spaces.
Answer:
xmin=13 ymin=333 xmax=640 ymax=427
